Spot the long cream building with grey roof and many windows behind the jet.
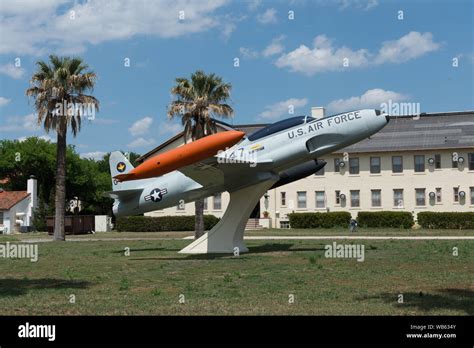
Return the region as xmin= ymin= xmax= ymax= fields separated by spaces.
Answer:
xmin=140 ymin=108 xmax=474 ymax=228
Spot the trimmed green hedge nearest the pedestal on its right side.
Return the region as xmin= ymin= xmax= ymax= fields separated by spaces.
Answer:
xmin=288 ymin=211 xmax=351 ymax=228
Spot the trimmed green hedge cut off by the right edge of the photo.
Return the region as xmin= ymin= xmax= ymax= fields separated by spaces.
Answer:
xmin=417 ymin=211 xmax=474 ymax=230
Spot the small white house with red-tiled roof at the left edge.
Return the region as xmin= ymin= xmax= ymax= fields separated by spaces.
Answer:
xmin=0 ymin=177 xmax=38 ymax=234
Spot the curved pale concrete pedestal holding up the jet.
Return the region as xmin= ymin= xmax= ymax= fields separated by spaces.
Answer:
xmin=180 ymin=180 xmax=276 ymax=254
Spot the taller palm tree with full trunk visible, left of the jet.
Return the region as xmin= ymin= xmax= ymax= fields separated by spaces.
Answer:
xmin=26 ymin=55 xmax=99 ymax=241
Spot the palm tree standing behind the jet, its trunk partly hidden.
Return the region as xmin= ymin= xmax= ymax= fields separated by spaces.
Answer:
xmin=168 ymin=71 xmax=234 ymax=239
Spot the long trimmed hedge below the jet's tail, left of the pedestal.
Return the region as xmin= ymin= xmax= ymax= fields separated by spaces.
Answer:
xmin=115 ymin=215 xmax=219 ymax=232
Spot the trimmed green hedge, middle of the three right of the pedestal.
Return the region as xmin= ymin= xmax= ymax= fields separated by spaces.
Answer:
xmin=357 ymin=211 xmax=414 ymax=228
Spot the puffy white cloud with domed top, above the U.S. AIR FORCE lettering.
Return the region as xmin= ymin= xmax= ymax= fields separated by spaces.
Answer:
xmin=275 ymin=35 xmax=369 ymax=75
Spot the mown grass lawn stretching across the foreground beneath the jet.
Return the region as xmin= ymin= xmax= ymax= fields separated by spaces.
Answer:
xmin=0 ymin=231 xmax=474 ymax=315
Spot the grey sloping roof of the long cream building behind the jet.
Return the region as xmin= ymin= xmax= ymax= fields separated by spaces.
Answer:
xmin=137 ymin=111 xmax=474 ymax=162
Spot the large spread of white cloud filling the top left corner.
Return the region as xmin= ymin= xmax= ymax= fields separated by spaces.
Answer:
xmin=0 ymin=0 xmax=228 ymax=55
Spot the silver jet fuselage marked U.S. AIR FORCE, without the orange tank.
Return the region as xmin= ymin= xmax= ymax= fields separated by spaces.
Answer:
xmin=113 ymin=109 xmax=388 ymax=216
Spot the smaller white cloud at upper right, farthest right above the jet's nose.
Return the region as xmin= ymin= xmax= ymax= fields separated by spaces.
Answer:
xmin=375 ymin=31 xmax=441 ymax=64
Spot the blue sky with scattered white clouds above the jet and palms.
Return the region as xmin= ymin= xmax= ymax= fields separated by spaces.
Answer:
xmin=0 ymin=0 xmax=474 ymax=157
